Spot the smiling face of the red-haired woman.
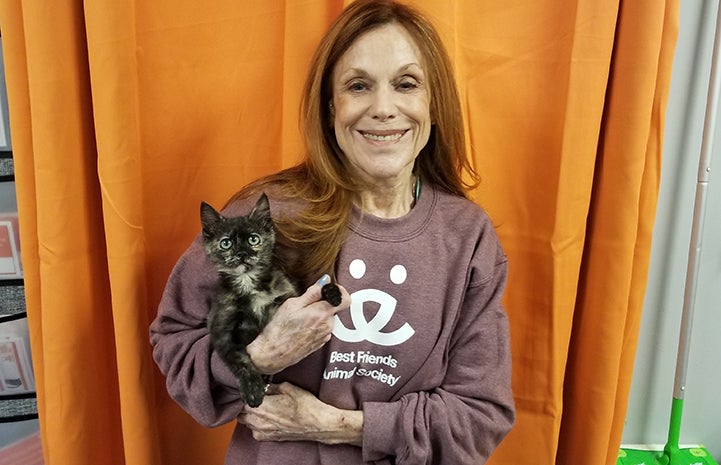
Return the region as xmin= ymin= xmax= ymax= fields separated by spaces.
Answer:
xmin=331 ymin=24 xmax=431 ymax=186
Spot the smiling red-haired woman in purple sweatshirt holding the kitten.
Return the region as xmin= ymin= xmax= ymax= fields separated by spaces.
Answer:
xmin=151 ymin=1 xmax=514 ymax=465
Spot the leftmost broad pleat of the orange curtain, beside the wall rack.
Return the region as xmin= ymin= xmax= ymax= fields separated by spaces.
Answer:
xmin=0 ymin=2 xmax=124 ymax=464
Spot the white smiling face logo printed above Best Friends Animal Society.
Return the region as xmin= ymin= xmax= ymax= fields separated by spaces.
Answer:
xmin=333 ymin=258 xmax=415 ymax=346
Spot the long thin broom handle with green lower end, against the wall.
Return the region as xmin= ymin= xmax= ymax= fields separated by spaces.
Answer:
xmin=662 ymin=2 xmax=721 ymax=465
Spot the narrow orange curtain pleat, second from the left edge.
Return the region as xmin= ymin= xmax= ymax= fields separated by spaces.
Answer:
xmin=84 ymin=2 xmax=161 ymax=464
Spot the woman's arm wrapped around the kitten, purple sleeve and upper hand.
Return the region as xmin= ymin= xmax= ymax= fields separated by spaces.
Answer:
xmin=150 ymin=238 xmax=350 ymax=426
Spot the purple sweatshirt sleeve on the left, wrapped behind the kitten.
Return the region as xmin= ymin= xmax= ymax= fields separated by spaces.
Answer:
xmin=150 ymin=237 xmax=243 ymax=427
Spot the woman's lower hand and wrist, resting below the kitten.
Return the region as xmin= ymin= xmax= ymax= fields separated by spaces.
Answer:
xmin=238 ymin=383 xmax=363 ymax=446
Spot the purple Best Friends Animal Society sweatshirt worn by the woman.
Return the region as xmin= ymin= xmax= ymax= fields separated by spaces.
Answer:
xmin=150 ymin=186 xmax=514 ymax=465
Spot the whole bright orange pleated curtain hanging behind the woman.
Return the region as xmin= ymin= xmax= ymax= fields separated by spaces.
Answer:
xmin=0 ymin=0 xmax=679 ymax=465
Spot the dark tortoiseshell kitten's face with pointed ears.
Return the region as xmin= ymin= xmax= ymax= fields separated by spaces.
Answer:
xmin=200 ymin=194 xmax=275 ymax=274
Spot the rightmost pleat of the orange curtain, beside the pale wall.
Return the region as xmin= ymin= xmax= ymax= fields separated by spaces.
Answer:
xmin=557 ymin=2 xmax=677 ymax=464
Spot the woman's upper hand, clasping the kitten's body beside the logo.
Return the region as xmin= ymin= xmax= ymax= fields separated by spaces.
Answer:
xmin=246 ymin=275 xmax=350 ymax=375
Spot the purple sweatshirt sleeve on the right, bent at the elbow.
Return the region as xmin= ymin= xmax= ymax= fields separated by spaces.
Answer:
xmin=363 ymin=245 xmax=515 ymax=465
